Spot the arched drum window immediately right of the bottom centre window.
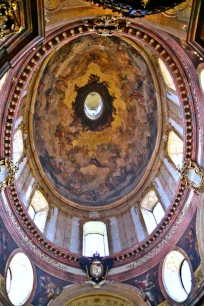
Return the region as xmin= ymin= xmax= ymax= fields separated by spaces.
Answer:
xmin=141 ymin=190 xmax=165 ymax=234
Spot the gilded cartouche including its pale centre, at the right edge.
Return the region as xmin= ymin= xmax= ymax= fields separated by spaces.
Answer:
xmin=178 ymin=159 xmax=204 ymax=193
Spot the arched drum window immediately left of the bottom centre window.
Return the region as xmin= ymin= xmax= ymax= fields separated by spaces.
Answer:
xmin=28 ymin=190 xmax=49 ymax=232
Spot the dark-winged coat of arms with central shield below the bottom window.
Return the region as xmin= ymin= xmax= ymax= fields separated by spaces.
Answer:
xmin=80 ymin=252 xmax=113 ymax=288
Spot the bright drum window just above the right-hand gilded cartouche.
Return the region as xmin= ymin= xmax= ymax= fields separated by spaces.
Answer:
xmin=167 ymin=131 xmax=183 ymax=167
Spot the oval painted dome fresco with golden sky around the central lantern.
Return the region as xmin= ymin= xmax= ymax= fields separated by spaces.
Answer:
xmin=33 ymin=35 xmax=158 ymax=206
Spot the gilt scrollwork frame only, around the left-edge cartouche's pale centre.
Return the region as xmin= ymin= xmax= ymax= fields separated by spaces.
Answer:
xmin=0 ymin=159 xmax=18 ymax=192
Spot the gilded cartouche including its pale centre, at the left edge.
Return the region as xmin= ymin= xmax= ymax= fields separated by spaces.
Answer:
xmin=0 ymin=159 xmax=18 ymax=192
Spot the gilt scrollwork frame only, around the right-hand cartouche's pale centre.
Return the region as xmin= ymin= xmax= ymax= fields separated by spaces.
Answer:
xmin=179 ymin=159 xmax=204 ymax=193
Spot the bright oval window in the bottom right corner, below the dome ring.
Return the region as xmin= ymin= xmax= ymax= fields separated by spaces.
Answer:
xmin=162 ymin=250 xmax=192 ymax=303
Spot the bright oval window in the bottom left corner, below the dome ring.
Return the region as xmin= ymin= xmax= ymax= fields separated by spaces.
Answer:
xmin=6 ymin=252 xmax=34 ymax=306
